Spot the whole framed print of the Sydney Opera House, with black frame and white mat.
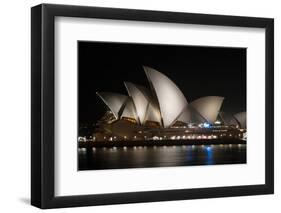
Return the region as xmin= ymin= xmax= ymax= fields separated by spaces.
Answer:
xmin=31 ymin=4 xmax=274 ymax=208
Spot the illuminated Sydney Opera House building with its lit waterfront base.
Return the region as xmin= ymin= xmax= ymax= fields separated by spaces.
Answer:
xmin=89 ymin=67 xmax=246 ymax=142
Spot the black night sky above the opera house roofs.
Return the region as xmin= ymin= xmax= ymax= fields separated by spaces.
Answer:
xmin=78 ymin=41 xmax=246 ymax=123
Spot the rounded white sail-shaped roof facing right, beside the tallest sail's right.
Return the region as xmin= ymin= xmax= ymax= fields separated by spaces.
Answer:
xmin=190 ymin=96 xmax=224 ymax=123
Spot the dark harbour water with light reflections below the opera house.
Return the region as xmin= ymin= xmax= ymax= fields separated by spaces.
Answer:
xmin=78 ymin=144 xmax=246 ymax=170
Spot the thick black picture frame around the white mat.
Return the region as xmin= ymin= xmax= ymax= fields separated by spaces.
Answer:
xmin=31 ymin=4 xmax=274 ymax=209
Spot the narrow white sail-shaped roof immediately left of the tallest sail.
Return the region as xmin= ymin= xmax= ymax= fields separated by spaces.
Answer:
xmin=124 ymin=82 xmax=150 ymax=124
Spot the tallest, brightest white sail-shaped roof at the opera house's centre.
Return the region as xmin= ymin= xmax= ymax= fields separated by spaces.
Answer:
xmin=144 ymin=67 xmax=187 ymax=127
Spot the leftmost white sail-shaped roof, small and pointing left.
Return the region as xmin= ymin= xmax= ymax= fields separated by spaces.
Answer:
xmin=96 ymin=92 xmax=128 ymax=119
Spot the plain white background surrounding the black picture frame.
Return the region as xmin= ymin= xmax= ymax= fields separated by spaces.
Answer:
xmin=0 ymin=0 xmax=281 ymax=213
